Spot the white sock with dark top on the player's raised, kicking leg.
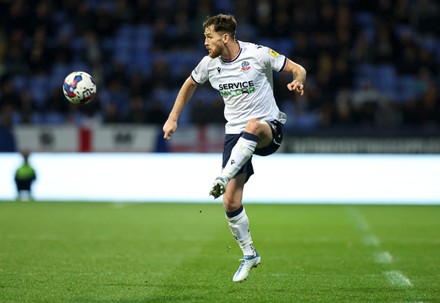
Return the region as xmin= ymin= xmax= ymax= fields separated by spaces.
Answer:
xmin=222 ymin=132 xmax=258 ymax=181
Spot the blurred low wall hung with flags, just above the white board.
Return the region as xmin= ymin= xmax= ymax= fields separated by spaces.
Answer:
xmin=14 ymin=124 xmax=440 ymax=154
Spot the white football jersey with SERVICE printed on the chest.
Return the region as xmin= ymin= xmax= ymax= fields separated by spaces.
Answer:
xmin=191 ymin=41 xmax=287 ymax=134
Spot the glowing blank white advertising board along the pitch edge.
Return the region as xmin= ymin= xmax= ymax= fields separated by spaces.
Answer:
xmin=0 ymin=153 xmax=440 ymax=204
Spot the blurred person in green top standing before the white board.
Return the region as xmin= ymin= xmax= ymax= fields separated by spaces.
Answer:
xmin=15 ymin=152 xmax=37 ymax=201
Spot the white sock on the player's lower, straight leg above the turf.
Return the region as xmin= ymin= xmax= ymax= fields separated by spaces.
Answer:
xmin=226 ymin=208 xmax=257 ymax=256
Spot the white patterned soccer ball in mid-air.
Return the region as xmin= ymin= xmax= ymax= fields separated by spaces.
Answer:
xmin=63 ymin=71 xmax=96 ymax=104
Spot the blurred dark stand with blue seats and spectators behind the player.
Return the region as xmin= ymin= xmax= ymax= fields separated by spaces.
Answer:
xmin=0 ymin=0 xmax=440 ymax=152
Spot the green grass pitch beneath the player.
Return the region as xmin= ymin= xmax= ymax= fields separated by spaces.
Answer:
xmin=0 ymin=202 xmax=440 ymax=303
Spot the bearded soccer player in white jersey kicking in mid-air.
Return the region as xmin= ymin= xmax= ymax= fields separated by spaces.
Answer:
xmin=163 ymin=14 xmax=306 ymax=282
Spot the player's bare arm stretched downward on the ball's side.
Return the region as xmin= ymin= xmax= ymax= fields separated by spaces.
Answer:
xmin=162 ymin=77 xmax=197 ymax=140
